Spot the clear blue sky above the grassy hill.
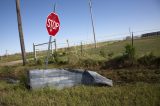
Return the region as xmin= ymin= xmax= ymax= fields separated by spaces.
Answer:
xmin=0 ymin=0 xmax=160 ymax=55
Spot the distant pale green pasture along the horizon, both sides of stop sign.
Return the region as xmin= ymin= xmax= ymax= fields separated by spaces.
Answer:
xmin=0 ymin=37 xmax=160 ymax=62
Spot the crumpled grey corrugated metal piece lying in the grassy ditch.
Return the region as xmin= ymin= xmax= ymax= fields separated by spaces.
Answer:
xmin=28 ymin=69 xmax=113 ymax=89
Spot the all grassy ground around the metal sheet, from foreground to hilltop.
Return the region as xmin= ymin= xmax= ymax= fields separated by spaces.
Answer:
xmin=0 ymin=37 xmax=160 ymax=106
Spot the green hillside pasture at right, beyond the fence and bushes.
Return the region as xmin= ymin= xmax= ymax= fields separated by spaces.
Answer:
xmin=87 ymin=37 xmax=160 ymax=57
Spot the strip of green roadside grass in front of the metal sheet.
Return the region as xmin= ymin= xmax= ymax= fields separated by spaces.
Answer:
xmin=0 ymin=81 xmax=160 ymax=106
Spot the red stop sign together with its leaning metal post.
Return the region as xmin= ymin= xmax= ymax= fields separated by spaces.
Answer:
xmin=45 ymin=4 xmax=60 ymax=68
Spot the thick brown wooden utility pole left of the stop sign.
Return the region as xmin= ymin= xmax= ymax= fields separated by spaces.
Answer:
xmin=16 ymin=0 xmax=26 ymax=65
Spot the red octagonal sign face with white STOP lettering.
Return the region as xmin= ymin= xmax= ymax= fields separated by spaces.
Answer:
xmin=46 ymin=12 xmax=60 ymax=36
